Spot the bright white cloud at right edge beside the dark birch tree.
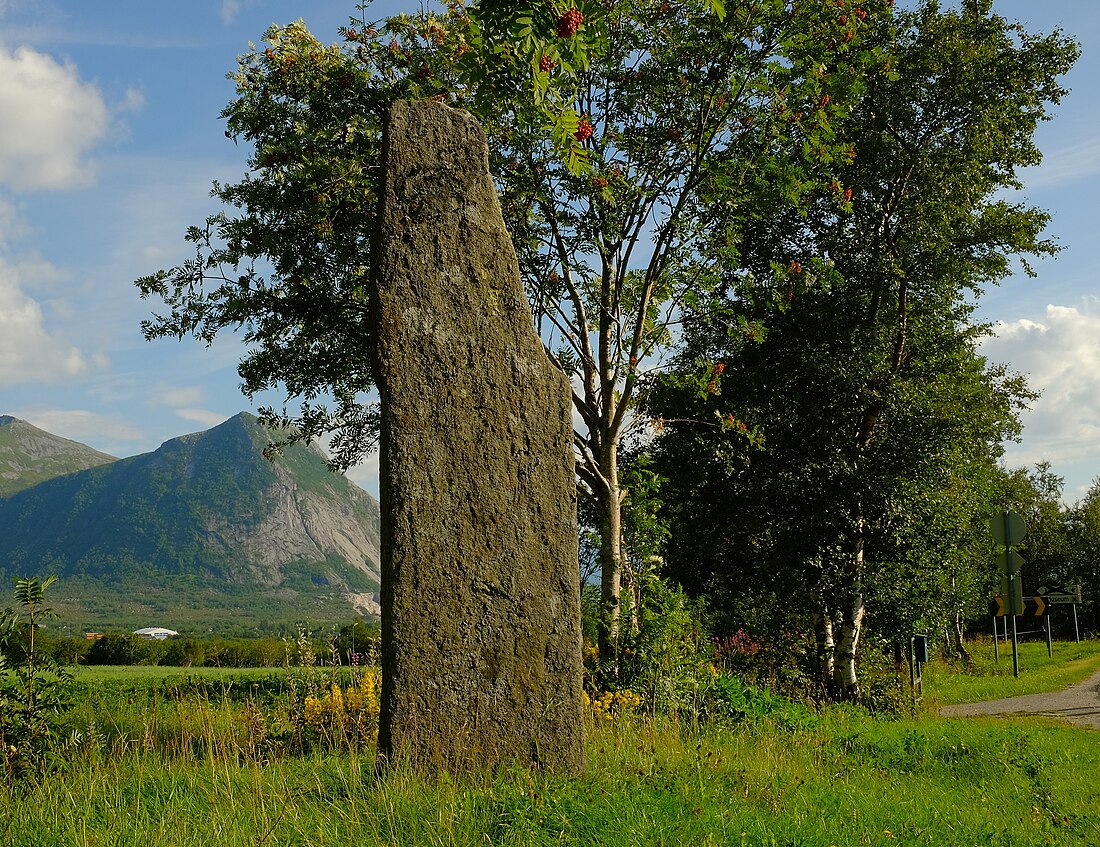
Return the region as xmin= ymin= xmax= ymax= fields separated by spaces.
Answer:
xmin=981 ymin=300 xmax=1100 ymax=501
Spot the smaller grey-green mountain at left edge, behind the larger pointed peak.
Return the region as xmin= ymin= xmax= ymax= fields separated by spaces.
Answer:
xmin=0 ymin=415 xmax=117 ymax=497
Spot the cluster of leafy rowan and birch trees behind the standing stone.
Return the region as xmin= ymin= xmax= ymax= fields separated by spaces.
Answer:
xmin=138 ymin=0 xmax=1091 ymax=700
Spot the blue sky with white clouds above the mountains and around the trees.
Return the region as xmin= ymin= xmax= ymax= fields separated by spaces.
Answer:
xmin=0 ymin=0 xmax=1100 ymax=503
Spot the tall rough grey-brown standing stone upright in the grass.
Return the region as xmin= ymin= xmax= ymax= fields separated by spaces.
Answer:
xmin=372 ymin=101 xmax=584 ymax=771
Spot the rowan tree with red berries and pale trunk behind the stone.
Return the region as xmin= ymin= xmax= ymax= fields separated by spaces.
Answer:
xmin=139 ymin=0 xmax=892 ymax=649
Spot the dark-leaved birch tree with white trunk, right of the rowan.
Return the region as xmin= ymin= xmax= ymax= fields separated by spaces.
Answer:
xmin=642 ymin=0 xmax=1077 ymax=697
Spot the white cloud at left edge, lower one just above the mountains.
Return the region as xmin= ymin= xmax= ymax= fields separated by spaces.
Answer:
xmin=0 ymin=256 xmax=89 ymax=387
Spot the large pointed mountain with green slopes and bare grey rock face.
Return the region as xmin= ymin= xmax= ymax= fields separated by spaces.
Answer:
xmin=0 ymin=414 xmax=380 ymax=631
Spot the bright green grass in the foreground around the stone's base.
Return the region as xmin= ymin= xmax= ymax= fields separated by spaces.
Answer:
xmin=0 ymin=644 xmax=1100 ymax=847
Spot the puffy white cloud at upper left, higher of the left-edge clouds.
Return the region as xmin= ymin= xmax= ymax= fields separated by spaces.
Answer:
xmin=0 ymin=45 xmax=110 ymax=191
